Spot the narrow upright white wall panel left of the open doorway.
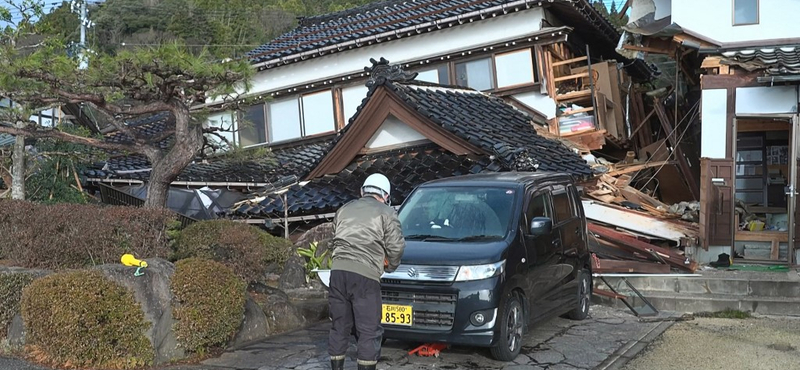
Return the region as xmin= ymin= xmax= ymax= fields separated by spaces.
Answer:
xmin=700 ymin=89 xmax=730 ymax=158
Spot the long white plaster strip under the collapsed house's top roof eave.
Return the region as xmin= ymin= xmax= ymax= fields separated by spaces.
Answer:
xmin=250 ymin=7 xmax=544 ymax=93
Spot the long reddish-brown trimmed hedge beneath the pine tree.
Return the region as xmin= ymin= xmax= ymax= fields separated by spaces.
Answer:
xmin=0 ymin=200 xmax=179 ymax=270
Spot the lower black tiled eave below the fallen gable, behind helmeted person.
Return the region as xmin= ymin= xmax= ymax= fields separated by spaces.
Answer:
xmin=228 ymin=144 xmax=502 ymax=218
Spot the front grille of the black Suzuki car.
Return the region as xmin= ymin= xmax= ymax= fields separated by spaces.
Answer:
xmin=381 ymin=290 xmax=458 ymax=330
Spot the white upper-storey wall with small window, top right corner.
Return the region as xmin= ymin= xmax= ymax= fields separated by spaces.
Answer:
xmin=672 ymin=0 xmax=800 ymax=42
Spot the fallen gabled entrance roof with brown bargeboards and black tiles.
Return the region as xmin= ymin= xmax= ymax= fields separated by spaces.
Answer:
xmin=229 ymin=59 xmax=592 ymax=218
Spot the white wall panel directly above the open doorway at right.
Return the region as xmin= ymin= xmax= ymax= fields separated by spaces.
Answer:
xmin=736 ymin=85 xmax=800 ymax=115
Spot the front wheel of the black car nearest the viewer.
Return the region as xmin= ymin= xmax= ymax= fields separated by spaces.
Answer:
xmin=491 ymin=294 xmax=525 ymax=361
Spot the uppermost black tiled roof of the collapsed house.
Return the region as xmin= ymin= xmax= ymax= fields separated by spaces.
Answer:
xmin=247 ymin=0 xmax=651 ymax=78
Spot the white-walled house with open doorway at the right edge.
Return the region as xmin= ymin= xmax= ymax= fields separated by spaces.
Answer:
xmin=618 ymin=0 xmax=800 ymax=264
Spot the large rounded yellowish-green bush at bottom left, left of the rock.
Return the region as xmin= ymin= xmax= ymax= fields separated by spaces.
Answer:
xmin=21 ymin=270 xmax=155 ymax=369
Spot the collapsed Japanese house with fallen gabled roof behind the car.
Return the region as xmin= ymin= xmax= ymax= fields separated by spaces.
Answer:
xmin=78 ymin=0 xmax=720 ymax=271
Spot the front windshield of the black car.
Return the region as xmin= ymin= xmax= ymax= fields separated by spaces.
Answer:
xmin=398 ymin=187 xmax=516 ymax=241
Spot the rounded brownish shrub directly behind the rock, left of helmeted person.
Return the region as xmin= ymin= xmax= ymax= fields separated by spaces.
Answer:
xmin=172 ymin=220 xmax=292 ymax=282
